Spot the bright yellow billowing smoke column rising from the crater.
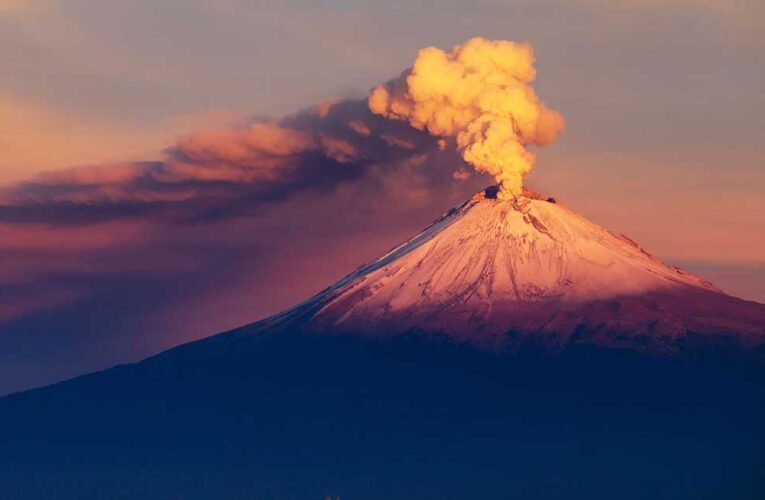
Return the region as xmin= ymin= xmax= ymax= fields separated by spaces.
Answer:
xmin=368 ymin=37 xmax=564 ymax=199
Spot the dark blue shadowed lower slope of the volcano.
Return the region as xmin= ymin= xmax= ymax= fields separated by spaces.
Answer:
xmin=0 ymin=331 xmax=765 ymax=499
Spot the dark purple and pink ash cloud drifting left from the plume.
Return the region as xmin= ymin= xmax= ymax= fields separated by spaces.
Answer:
xmin=0 ymin=93 xmax=472 ymax=224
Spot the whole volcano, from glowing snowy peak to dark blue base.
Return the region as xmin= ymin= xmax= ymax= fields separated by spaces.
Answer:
xmin=0 ymin=188 xmax=765 ymax=499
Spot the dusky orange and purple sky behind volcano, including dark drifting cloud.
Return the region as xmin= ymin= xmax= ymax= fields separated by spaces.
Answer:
xmin=0 ymin=0 xmax=765 ymax=393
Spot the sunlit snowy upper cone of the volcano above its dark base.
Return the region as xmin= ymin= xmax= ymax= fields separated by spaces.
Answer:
xmin=247 ymin=188 xmax=765 ymax=352
